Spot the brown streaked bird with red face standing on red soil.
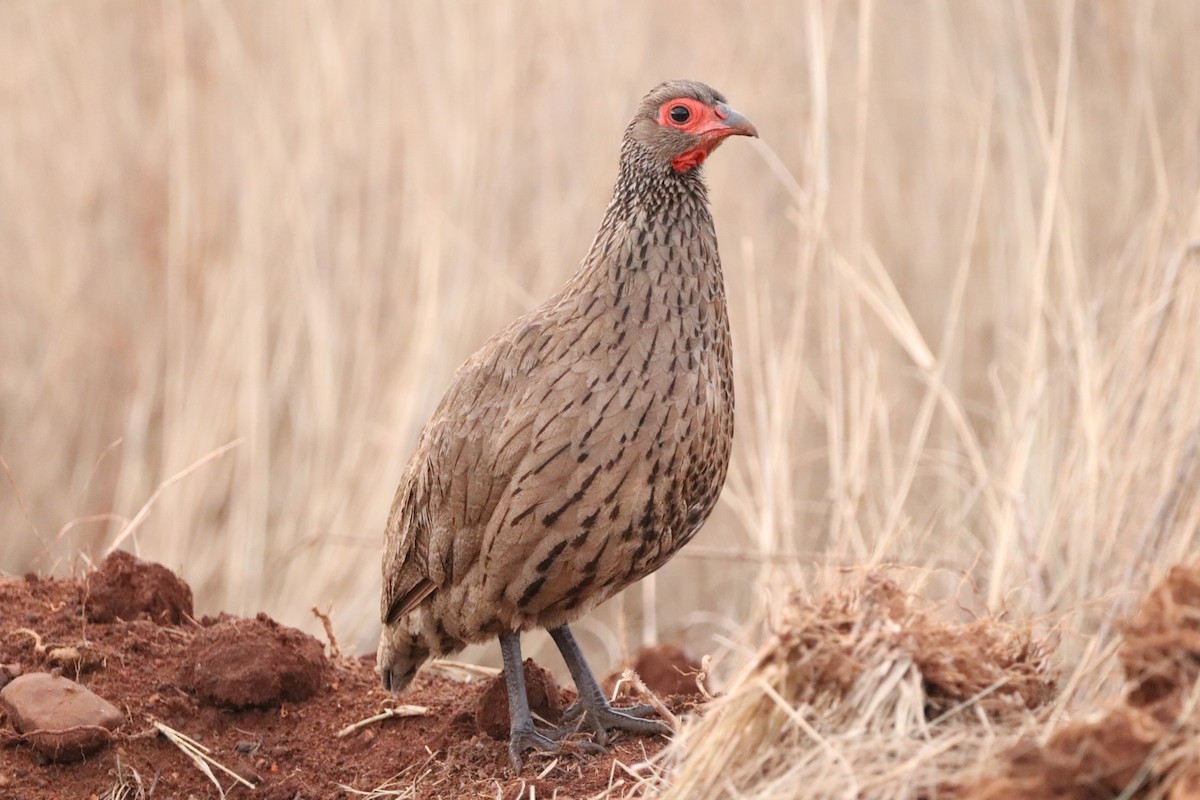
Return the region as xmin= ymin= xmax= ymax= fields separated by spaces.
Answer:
xmin=377 ymin=80 xmax=758 ymax=772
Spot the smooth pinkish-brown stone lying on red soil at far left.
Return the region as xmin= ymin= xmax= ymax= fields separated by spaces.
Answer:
xmin=0 ymin=672 xmax=125 ymax=762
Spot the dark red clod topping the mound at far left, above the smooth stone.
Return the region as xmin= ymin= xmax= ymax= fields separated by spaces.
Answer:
xmin=79 ymin=551 xmax=192 ymax=625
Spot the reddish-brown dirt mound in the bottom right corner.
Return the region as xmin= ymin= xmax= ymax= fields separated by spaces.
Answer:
xmin=965 ymin=561 xmax=1200 ymax=800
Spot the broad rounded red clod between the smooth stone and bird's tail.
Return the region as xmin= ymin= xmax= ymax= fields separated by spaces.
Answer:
xmin=180 ymin=614 xmax=328 ymax=709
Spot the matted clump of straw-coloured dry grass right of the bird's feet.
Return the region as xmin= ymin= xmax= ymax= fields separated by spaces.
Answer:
xmin=660 ymin=576 xmax=1057 ymax=800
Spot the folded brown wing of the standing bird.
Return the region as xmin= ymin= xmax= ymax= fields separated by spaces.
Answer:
xmin=380 ymin=315 xmax=545 ymax=624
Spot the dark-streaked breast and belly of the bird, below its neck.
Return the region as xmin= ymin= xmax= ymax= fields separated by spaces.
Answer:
xmin=458 ymin=217 xmax=733 ymax=625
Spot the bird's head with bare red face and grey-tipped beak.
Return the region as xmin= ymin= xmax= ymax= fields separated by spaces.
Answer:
xmin=626 ymin=80 xmax=758 ymax=173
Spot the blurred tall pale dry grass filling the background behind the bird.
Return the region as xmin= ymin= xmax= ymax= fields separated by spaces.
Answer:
xmin=0 ymin=0 xmax=1200 ymax=693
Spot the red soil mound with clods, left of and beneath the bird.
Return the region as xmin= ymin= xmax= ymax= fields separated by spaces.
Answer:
xmin=0 ymin=557 xmax=666 ymax=800
